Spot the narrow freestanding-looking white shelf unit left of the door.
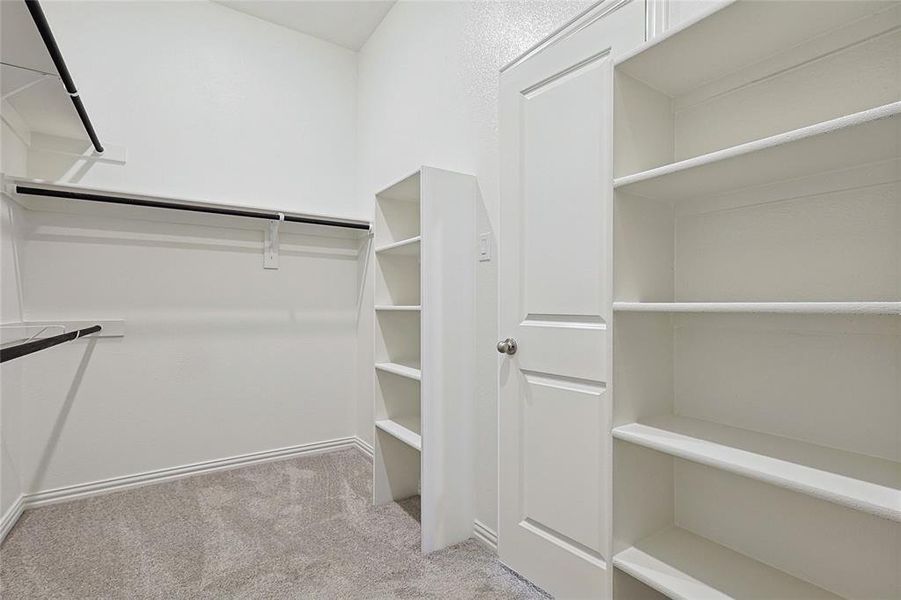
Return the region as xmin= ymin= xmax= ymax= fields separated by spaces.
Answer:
xmin=373 ymin=167 xmax=478 ymax=553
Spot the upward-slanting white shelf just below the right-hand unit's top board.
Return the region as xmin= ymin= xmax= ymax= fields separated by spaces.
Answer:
xmin=613 ymin=102 xmax=901 ymax=201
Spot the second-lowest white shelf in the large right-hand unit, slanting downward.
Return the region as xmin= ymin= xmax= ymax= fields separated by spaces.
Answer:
xmin=613 ymin=416 xmax=901 ymax=522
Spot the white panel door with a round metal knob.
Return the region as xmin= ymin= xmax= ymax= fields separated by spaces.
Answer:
xmin=498 ymin=2 xmax=644 ymax=598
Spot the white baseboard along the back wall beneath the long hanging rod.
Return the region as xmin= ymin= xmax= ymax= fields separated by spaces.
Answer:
xmin=25 ymin=437 xmax=358 ymax=509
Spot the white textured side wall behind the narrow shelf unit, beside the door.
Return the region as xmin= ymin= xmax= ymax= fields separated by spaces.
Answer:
xmin=357 ymin=1 xmax=592 ymax=529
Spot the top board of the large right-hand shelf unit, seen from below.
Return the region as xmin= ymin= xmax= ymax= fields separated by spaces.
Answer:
xmin=617 ymin=0 xmax=892 ymax=97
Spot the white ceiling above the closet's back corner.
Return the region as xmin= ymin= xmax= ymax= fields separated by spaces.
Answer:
xmin=216 ymin=0 xmax=395 ymax=50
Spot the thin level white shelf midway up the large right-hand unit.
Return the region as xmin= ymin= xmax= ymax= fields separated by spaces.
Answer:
xmin=613 ymin=302 xmax=901 ymax=315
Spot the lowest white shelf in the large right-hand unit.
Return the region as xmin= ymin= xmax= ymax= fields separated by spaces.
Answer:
xmin=613 ymin=527 xmax=839 ymax=600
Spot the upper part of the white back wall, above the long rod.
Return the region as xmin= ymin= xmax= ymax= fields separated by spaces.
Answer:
xmin=29 ymin=1 xmax=371 ymax=217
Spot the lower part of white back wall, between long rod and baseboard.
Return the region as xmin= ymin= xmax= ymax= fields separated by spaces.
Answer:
xmin=13 ymin=211 xmax=358 ymax=491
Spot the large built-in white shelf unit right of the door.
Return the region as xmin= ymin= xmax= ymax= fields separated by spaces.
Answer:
xmin=612 ymin=0 xmax=901 ymax=598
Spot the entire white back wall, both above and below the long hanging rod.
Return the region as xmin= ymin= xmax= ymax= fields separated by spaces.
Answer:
xmin=0 ymin=1 xmax=369 ymax=506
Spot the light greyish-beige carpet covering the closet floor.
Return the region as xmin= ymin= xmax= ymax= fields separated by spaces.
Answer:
xmin=0 ymin=450 xmax=546 ymax=600
